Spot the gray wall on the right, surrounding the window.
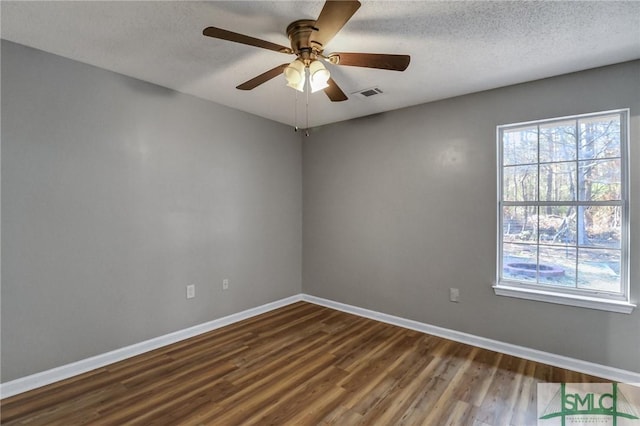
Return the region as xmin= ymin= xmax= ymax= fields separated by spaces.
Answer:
xmin=303 ymin=61 xmax=640 ymax=372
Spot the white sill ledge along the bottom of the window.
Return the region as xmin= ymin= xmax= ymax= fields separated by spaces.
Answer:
xmin=493 ymin=284 xmax=636 ymax=314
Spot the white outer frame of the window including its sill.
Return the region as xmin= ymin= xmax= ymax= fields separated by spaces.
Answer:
xmin=493 ymin=108 xmax=636 ymax=314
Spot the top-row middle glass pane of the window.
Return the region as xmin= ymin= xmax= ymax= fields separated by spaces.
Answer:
xmin=540 ymin=120 xmax=577 ymax=163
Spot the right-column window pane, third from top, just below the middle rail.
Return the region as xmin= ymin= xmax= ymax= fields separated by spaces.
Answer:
xmin=579 ymin=206 xmax=622 ymax=249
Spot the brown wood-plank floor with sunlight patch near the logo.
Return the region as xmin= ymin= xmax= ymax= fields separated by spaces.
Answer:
xmin=1 ymin=302 xmax=603 ymax=426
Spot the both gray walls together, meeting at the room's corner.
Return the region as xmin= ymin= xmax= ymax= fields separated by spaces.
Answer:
xmin=1 ymin=41 xmax=640 ymax=382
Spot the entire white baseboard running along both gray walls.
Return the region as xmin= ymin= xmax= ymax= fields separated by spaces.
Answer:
xmin=0 ymin=294 xmax=640 ymax=398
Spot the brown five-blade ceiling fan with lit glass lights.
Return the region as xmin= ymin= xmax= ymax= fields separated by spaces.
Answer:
xmin=202 ymin=0 xmax=411 ymax=102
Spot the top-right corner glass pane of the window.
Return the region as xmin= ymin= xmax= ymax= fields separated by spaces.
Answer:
xmin=579 ymin=114 xmax=620 ymax=160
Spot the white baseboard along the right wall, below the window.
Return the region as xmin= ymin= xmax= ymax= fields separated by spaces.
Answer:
xmin=302 ymin=294 xmax=640 ymax=383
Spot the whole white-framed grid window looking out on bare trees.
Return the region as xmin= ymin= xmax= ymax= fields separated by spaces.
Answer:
xmin=494 ymin=110 xmax=634 ymax=312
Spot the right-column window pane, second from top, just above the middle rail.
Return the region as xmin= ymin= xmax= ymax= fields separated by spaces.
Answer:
xmin=578 ymin=160 xmax=622 ymax=201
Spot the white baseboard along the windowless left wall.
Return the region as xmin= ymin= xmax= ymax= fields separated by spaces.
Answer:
xmin=0 ymin=294 xmax=302 ymax=398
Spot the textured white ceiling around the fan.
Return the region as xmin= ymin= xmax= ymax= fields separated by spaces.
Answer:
xmin=0 ymin=0 xmax=640 ymax=127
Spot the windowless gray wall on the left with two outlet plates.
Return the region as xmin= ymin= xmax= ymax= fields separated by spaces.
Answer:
xmin=1 ymin=41 xmax=302 ymax=382
